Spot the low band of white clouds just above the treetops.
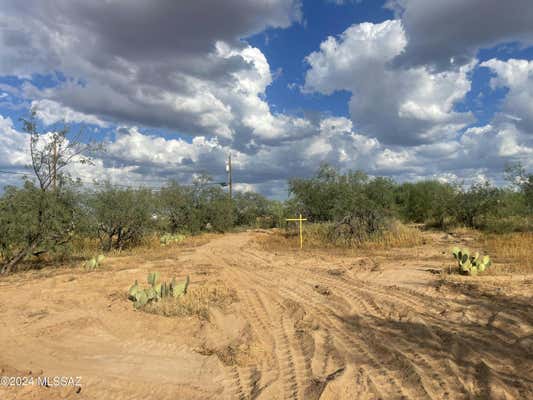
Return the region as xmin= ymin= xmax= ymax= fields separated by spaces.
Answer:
xmin=0 ymin=108 xmax=533 ymax=198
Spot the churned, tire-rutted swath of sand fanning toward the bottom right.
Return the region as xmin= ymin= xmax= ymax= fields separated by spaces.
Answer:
xmin=197 ymin=235 xmax=533 ymax=400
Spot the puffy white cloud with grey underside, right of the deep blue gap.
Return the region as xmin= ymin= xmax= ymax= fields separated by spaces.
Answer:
xmin=304 ymin=20 xmax=474 ymax=146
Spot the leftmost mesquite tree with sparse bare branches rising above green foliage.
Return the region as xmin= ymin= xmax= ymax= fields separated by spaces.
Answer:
xmin=0 ymin=110 xmax=96 ymax=274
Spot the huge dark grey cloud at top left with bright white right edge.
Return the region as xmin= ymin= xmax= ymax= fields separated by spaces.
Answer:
xmin=0 ymin=0 xmax=301 ymax=142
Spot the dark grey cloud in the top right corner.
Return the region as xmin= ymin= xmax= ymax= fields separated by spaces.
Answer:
xmin=387 ymin=0 xmax=533 ymax=70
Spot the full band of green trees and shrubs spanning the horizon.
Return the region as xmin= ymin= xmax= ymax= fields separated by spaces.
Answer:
xmin=0 ymin=113 xmax=533 ymax=273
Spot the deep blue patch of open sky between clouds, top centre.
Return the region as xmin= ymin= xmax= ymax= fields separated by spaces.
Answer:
xmin=246 ymin=1 xmax=394 ymax=117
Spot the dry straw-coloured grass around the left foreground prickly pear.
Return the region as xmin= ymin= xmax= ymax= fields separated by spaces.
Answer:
xmin=142 ymin=281 xmax=237 ymax=320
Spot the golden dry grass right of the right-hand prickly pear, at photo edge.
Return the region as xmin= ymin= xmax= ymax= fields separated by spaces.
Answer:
xmin=480 ymin=232 xmax=533 ymax=273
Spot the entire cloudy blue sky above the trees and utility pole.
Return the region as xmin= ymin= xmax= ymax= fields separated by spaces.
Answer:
xmin=0 ymin=0 xmax=533 ymax=199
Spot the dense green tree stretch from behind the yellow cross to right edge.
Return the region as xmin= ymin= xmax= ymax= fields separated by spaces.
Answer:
xmin=288 ymin=164 xmax=533 ymax=232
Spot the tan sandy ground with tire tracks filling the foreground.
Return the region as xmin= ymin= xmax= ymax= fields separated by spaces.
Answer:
xmin=0 ymin=232 xmax=533 ymax=400
